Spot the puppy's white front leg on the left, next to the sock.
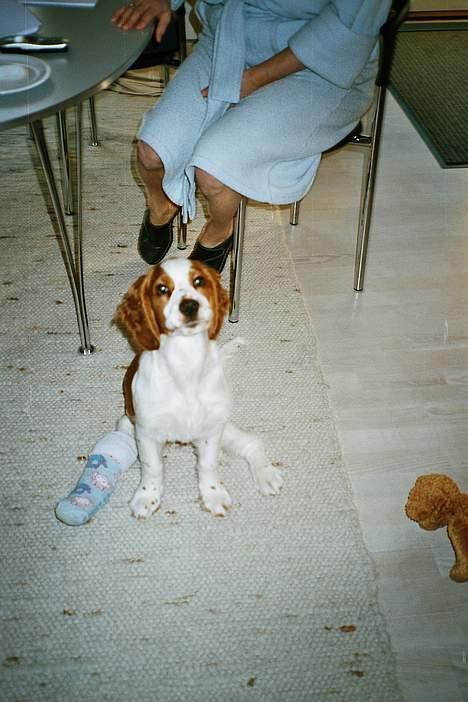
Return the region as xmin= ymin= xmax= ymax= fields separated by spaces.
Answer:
xmin=130 ymin=427 xmax=164 ymax=519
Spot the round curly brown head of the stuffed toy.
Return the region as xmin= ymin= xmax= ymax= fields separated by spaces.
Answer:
xmin=406 ymin=473 xmax=461 ymax=530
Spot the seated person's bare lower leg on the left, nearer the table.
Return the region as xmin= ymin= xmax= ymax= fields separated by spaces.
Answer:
xmin=137 ymin=141 xmax=179 ymax=225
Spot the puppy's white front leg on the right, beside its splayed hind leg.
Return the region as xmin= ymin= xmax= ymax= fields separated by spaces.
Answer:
xmin=195 ymin=432 xmax=232 ymax=517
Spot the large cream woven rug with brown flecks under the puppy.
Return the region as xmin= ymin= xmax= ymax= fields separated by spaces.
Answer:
xmin=0 ymin=92 xmax=400 ymax=702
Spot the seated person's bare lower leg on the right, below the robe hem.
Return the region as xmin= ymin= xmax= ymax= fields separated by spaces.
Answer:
xmin=196 ymin=168 xmax=241 ymax=248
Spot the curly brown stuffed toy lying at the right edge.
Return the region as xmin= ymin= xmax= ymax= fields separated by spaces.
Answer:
xmin=406 ymin=473 xmax=468 ymax=583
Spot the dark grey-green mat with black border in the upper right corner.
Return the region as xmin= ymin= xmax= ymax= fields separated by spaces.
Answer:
xmin=390 ymin=29 xmax=468 ymax=168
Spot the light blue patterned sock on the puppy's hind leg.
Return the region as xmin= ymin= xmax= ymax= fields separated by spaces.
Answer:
xmin=55 ymin=420 xmax=137 ymax=526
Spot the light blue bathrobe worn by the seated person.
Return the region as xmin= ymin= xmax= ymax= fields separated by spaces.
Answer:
xmin=138 ymin=0 xmax=391 ymax=221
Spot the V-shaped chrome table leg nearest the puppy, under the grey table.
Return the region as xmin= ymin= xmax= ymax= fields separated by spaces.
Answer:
xmin=31 ymin=105 xmax=94 ymax=355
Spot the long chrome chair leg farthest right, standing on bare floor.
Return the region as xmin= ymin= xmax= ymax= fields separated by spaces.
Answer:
xmin=354 ymin=87 xmax=385 ymax=292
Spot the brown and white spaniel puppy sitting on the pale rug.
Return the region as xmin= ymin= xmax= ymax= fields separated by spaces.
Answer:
xmin=116 ymin=258 xmax=282 ymax=519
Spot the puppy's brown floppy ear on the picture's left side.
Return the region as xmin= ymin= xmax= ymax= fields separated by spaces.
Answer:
xmin=114 ymin=269 xmax=161 ymax=352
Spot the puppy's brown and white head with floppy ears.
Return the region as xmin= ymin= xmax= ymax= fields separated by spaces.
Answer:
xmin=114 ymin=258 xmax=228 ymax=352
